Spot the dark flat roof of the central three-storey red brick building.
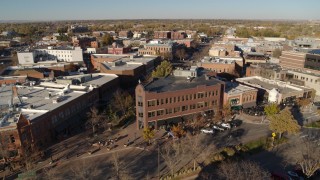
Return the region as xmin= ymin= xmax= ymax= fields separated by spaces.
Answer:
xmin=144 ymin=75 xmax=224 ymax=92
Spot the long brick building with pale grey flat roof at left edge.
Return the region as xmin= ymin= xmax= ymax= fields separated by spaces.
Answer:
xmin=0 ymin=73 xmax=119 ymax=157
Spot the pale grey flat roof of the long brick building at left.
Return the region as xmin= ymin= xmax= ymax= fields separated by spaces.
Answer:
xmin=0 ymin=73 xmax=118 ymax=128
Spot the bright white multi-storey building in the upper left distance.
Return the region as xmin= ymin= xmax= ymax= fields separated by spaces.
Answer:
xmin=18 ymin=46 xmax=83 ymax=65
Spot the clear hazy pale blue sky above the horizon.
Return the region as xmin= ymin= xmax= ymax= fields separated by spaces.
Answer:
xmin=0 ymin=0 xmax=320 ymax=20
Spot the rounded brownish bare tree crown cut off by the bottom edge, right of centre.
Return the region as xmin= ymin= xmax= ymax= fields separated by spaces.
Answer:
xmin=217 ymin=161 xmax=270 ymax=180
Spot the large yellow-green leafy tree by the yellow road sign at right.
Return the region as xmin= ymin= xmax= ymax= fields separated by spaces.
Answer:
xmin=269 ymin=109 xmax=300 ymax=139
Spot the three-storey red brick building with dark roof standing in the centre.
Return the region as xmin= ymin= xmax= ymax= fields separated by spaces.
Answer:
xmin=136 ymin=69 xmax=224 ymax=128
